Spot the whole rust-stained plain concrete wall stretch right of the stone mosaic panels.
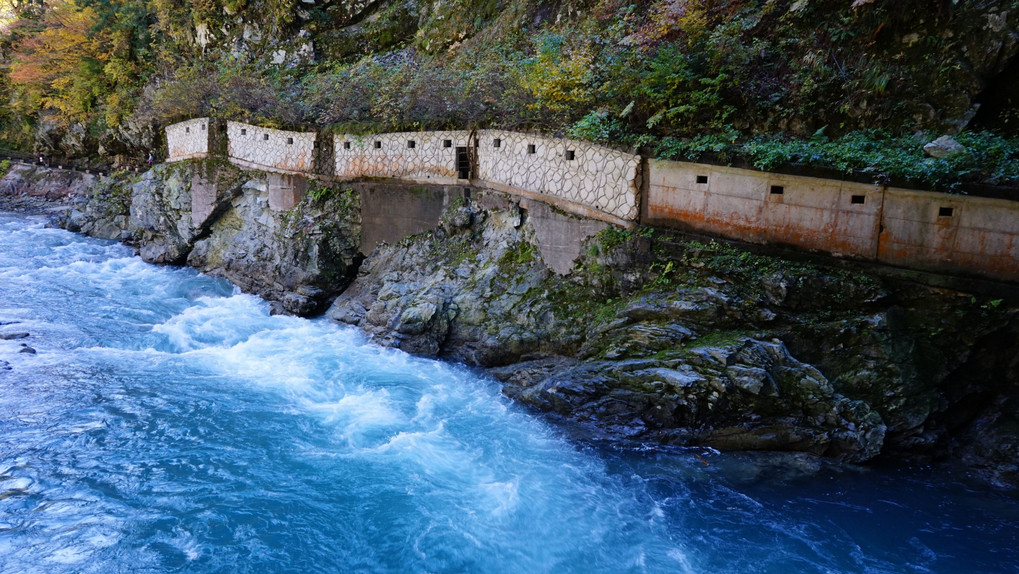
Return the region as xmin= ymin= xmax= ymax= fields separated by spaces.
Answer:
xmin=643 ymin=161 xmax=1019 ymax=281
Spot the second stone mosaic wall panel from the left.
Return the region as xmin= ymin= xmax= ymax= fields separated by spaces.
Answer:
xmin=226 ymin=121 xmax=315 ymax=173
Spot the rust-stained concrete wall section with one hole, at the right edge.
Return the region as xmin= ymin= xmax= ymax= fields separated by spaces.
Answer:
xmin=877 ymin=188 xmax=1019 ymax=281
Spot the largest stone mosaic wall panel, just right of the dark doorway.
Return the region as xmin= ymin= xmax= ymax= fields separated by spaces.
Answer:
xmin=478 ymin=129 xmax=640 ymax=221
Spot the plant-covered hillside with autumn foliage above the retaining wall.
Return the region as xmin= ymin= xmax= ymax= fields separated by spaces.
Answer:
xmin=0 ymin=0 xmax=1019 ymax=190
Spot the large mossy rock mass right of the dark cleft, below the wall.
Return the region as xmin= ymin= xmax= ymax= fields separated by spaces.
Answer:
xmin=328 ymin=195 xmax=1019 ymax=479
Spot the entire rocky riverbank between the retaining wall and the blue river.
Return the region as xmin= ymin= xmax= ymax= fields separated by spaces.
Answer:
xmin=7 ymin=162 xmax=1019 ymax=486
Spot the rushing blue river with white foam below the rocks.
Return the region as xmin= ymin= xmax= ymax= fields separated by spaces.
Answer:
xmin=0 ymin=214 xmax=1019 ymax=573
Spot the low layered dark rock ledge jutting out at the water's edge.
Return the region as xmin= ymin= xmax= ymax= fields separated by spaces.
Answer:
xmin=490 ymin=338 xmax=886 ymax=462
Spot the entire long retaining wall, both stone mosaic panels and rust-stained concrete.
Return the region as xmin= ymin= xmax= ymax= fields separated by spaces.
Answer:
xmin=166 ymin=118 xmax=1019 ymax=281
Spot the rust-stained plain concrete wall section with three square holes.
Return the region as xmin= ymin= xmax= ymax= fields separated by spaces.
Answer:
xmin=644 ymin=161 xmax=882 ymax=259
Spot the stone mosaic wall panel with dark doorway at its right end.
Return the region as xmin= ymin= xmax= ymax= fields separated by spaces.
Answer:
xmin=333 ymin=132 xmax=471 ymax=184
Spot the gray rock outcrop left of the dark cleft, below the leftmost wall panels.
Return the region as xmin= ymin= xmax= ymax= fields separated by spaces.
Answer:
xmin=57 ymin=162 xmax=360 ymax=315
